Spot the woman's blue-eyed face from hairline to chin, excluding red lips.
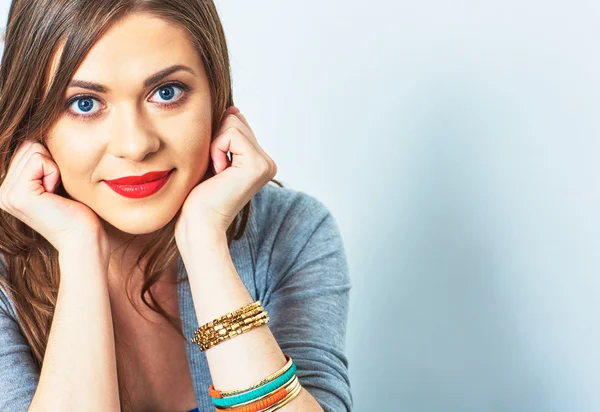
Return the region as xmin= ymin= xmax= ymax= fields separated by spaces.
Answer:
xmin=46 ymin=13 xmax=212 ymax=234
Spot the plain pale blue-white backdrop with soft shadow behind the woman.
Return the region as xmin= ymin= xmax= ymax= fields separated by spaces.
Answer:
xmin=1 ymin=0 xmax=600 ymax=412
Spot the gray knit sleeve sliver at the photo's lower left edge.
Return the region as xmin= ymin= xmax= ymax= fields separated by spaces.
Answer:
xmin=0 ymin=285 xmax=40 ymax=412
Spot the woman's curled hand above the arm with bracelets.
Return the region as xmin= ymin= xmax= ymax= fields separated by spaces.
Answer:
xmin=175 ymin=106 xmax=277 ymax=246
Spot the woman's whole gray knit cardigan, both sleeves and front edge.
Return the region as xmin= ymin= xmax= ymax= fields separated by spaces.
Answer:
xmin=0 ymin=183 xmax=353 ymax=412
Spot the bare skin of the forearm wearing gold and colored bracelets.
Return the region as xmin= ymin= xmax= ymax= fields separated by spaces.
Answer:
xmin=183 ymin=230 xmax=323 ymax=412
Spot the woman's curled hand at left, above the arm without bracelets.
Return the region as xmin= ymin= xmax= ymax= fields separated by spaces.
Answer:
xmin=0 ymin=140 xmax=108 ymax=252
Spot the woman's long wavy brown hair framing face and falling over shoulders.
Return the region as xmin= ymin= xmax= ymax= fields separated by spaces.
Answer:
xmin=0 ymin=0 xmax=283 ymax=409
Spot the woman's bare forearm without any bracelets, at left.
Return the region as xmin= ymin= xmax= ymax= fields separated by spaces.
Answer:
xmin=30 ymin=238 xmax=120 ymax=411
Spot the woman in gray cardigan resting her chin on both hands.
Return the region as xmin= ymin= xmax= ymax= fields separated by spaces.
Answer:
xmin=0 ymin=0 xmax=352 ymax=412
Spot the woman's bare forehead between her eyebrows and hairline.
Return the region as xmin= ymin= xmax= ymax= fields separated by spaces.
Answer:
xmin=46 ymin=13 xmax=203 ymax=95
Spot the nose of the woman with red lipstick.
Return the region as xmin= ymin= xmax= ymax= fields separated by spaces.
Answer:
xmin=108 ymin=106 xmax=161 ymax=162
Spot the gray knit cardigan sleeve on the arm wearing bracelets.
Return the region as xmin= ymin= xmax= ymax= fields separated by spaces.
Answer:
xmin=256 ymin=189 xmax=353 ymax=412
